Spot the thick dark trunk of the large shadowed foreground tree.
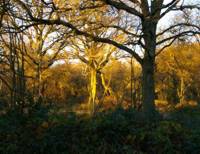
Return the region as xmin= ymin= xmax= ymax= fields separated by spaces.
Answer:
xmin=142 ymin=19 xmax=157 ymax=120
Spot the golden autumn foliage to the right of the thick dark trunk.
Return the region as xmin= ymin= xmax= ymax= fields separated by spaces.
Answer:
xmin=156 ymin=44 xmax=200 ymax=108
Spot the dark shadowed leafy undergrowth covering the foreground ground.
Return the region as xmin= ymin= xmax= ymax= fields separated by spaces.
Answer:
xmin=0 ymin=103 xmax=200 ymax=154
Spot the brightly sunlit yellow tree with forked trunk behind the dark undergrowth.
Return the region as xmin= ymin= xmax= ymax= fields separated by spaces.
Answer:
xmin=72 ymin=39 xmax=116 ymax=114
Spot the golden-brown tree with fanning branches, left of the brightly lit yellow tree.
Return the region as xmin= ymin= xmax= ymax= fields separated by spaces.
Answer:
xmin=21 ymin=26 xmax=64 ymax=100
